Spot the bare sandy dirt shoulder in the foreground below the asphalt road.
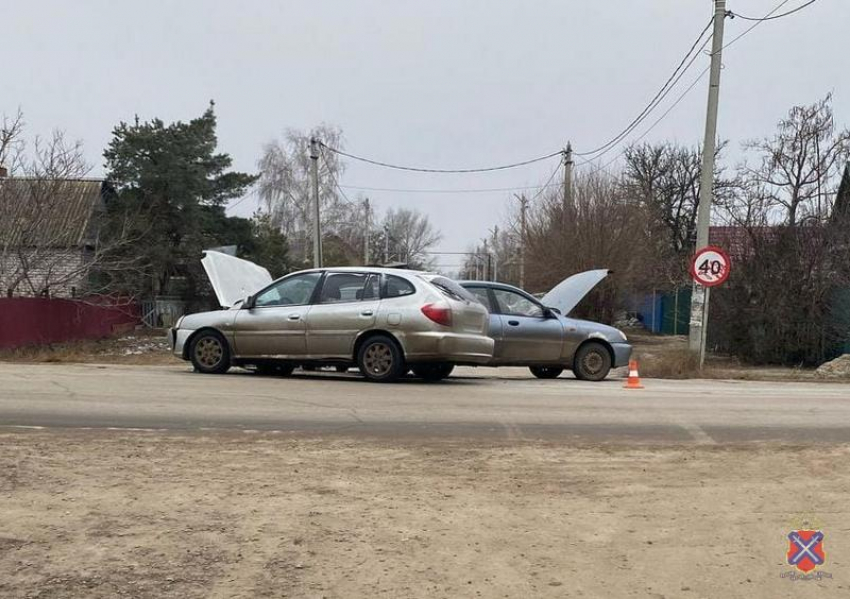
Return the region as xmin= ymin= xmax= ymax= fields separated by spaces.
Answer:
xmin=0 ymin=430 xmax=850 ymax=598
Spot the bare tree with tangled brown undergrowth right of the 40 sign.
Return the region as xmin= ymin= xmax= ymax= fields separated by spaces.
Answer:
xmin=711 ymin=96 xmax=850 ymax=365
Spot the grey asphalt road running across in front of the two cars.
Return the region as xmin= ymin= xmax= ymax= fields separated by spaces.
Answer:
xmin=0 ymin=363 xmax=850 ymax=444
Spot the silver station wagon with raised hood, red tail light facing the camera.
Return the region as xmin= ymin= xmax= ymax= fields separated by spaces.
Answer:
xmin=170 ymin=268 xmax=494 ymax=381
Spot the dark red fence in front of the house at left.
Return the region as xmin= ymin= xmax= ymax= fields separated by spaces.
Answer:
xmin=0 ymin=297 xmax=141 ymax=349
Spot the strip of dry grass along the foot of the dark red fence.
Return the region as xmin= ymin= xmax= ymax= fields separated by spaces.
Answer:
xmin=0 ymin=329 xmax=176 ymax=365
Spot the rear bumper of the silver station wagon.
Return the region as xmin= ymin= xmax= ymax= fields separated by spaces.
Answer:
xmin=401 ymin=331 xmax=495 ymax=364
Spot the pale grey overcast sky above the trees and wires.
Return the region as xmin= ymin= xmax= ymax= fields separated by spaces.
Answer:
xmin=0 ymin=0 xmax=850 ymax=270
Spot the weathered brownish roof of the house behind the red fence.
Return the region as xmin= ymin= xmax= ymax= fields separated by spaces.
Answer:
xmin=0 ymin=177 xmax=103 ymax=247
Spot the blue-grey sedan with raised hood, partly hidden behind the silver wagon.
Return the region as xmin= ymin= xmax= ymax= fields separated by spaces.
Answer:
xmin=460 ymin=271 xmax=632 ymax=381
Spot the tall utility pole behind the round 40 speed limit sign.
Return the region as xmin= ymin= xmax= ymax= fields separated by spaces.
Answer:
xmin=688 ymin=0 xmax=726 ymax=369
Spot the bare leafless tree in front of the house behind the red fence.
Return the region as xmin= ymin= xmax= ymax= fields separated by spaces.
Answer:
xmin=0 ymin=113 xmax=142 ymax=297
